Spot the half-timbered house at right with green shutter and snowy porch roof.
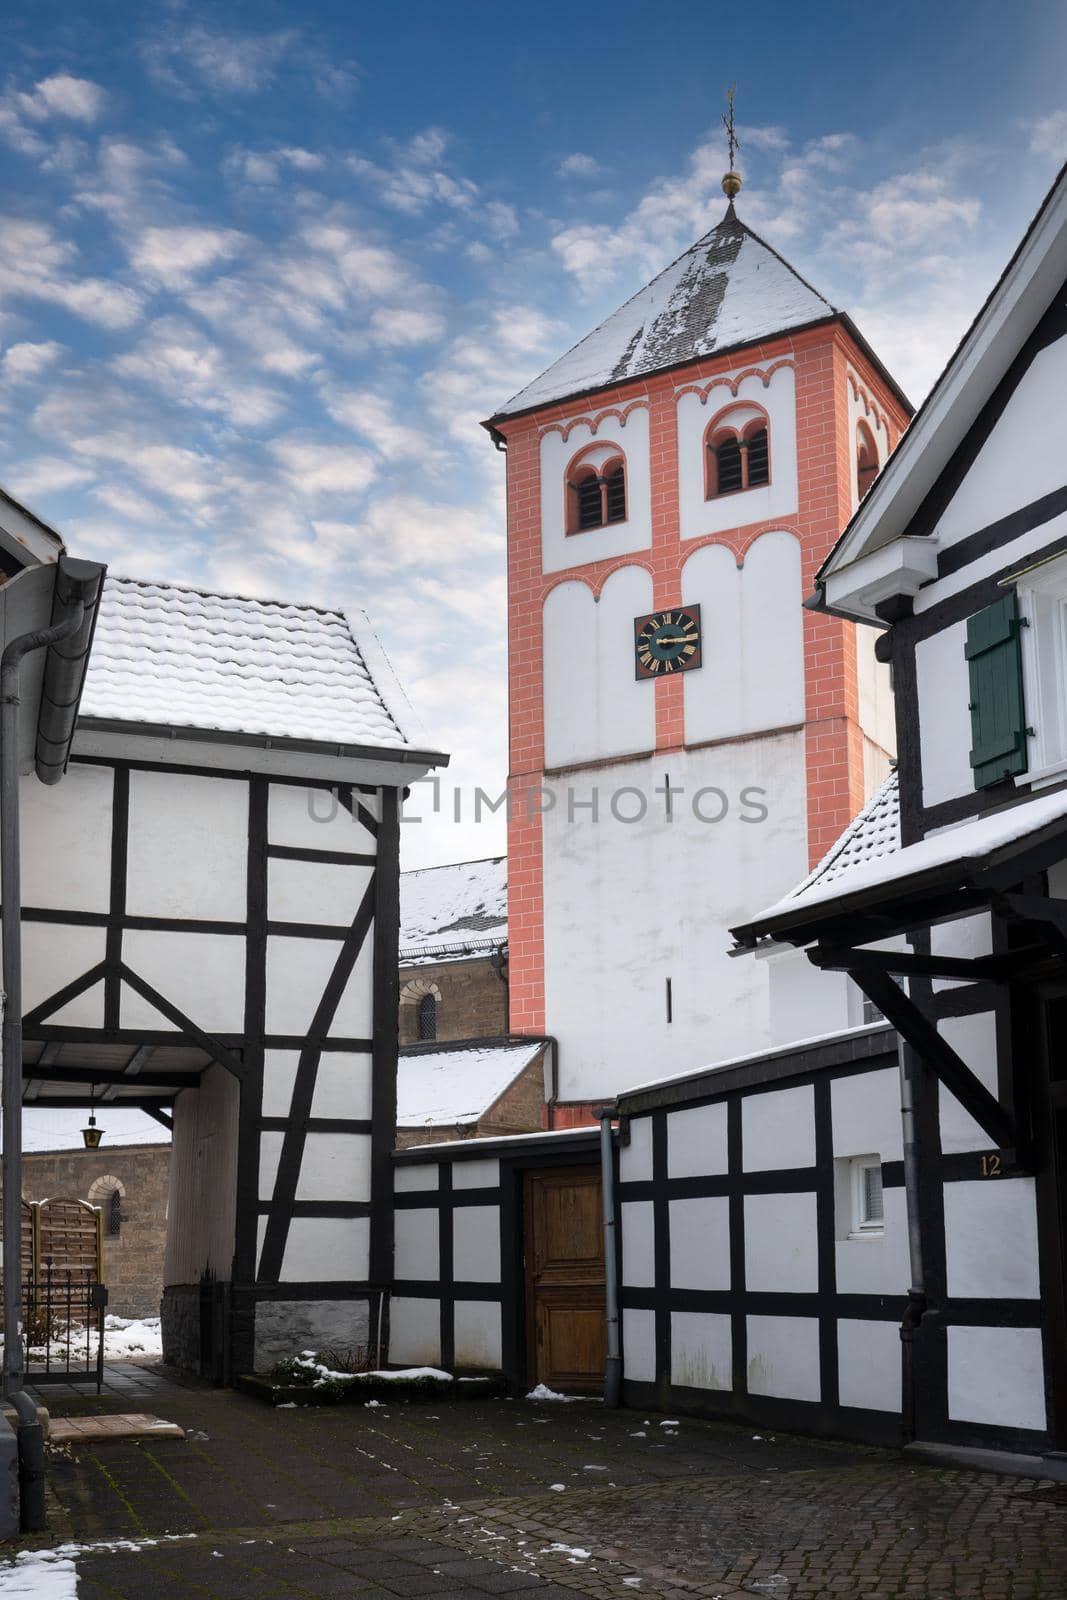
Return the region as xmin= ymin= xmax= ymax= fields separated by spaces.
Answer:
xmin=736 ymin=156 xmax=1067 ymax=1453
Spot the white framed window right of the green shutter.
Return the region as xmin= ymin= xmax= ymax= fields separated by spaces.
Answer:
xmin=1016 ymin=555 xmax=1067 ymax=787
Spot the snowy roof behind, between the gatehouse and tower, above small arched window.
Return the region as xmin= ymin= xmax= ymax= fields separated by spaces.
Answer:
xmin=400 ymin=856 xmax=507 ymax=963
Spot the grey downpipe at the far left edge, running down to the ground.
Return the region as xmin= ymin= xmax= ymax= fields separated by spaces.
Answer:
xmin=0 ymin=600 xmax=85 ymax=1533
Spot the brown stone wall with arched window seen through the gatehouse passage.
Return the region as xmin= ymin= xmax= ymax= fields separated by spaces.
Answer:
xmin=22 ymin=1145 xmax=171 ymax=1317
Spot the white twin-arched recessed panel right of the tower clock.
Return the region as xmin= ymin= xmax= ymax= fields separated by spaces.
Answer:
xmin=681 ymin=531 xmax=805 ymax=744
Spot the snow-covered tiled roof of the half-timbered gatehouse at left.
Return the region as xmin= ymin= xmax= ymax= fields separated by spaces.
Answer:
xmin=80 ymin=578 xmax=438 ymax=750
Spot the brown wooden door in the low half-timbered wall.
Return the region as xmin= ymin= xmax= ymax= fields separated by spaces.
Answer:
xmin=525 ymin=1166 xmax=606 ymax=1394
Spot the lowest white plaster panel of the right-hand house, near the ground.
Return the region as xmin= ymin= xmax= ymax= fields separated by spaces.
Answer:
xmin=949 ymin=1328 xmax=1046 ymax=1430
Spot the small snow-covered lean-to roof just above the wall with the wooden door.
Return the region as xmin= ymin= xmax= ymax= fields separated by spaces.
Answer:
xmin=397 ymin=1040 xmax=544 ymax=1130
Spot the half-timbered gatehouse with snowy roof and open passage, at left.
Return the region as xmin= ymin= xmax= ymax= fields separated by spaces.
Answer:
xmin=22 ymin=578 xmax=445 ymax=1378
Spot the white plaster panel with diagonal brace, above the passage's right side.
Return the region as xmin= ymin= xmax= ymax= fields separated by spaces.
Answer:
xmin=120 ymin=928 xmax=245 ymax=1034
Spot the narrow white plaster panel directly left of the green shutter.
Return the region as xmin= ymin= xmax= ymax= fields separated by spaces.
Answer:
xmin=915 ymin=621 xmax=974 ymax=805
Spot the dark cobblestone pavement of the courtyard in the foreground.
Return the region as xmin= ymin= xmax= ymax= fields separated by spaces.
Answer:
xmin=0 ymin=1374 xmax=1067 ymax=1600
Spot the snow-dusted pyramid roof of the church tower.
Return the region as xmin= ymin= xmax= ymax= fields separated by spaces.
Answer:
xmin=494 ymin=205 xmax=837 ymax=421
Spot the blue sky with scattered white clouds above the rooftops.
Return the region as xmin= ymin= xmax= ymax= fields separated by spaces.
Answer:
xmin=0 ymin=0 xmax=1067 ymax=866
